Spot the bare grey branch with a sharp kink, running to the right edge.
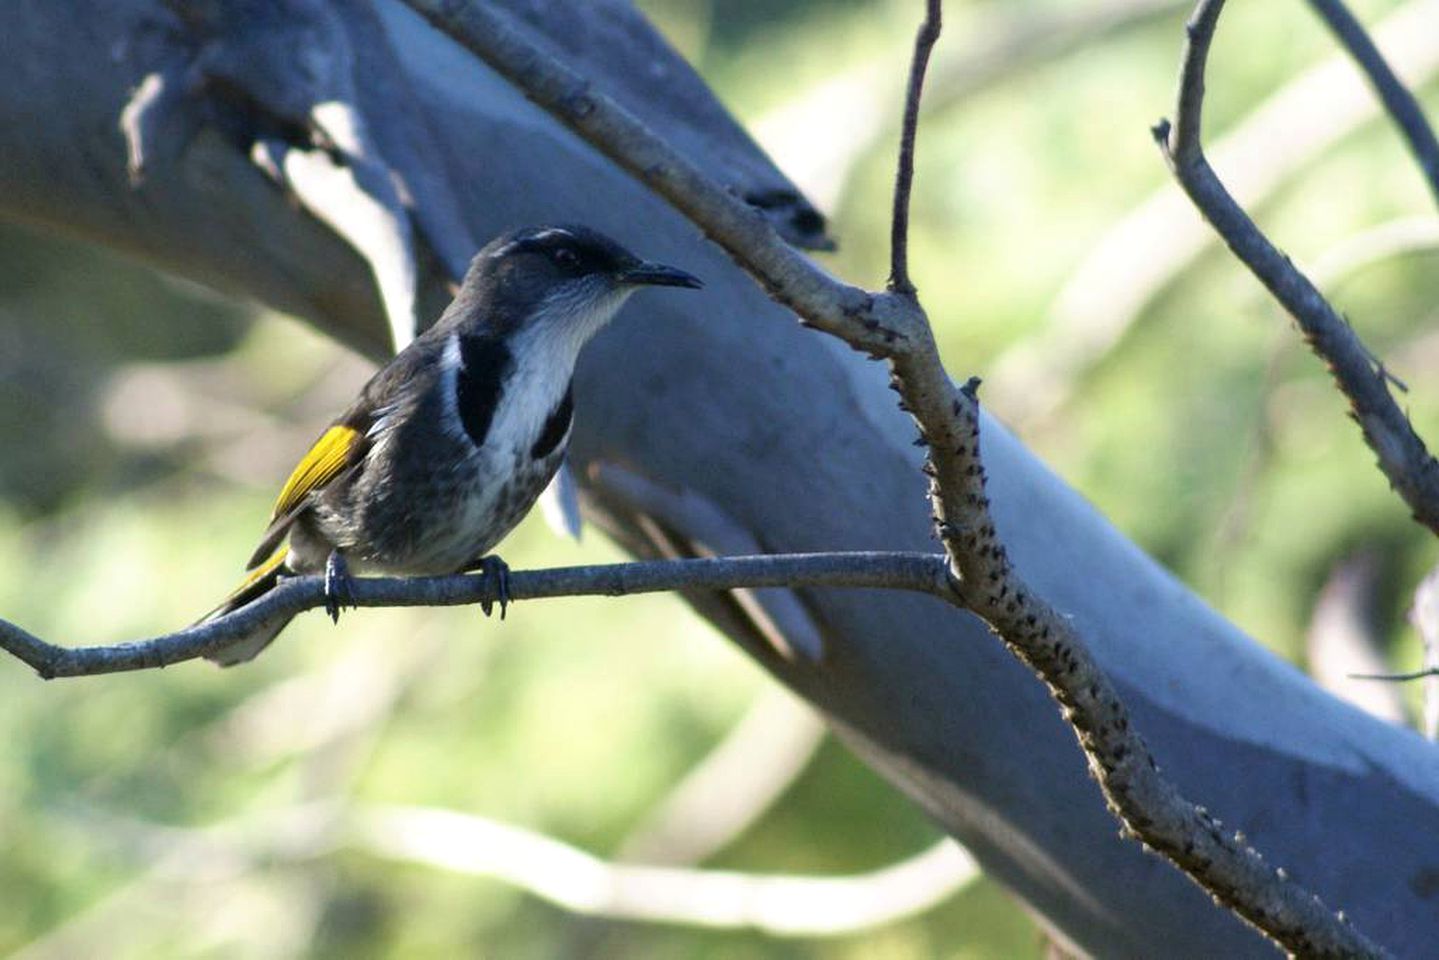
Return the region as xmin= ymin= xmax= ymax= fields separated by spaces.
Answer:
xmin=1154 ymin=0 xmax=1439 ymax=534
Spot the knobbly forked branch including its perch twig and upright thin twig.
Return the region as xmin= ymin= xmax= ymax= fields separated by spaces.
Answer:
xmin=0 ymin=0 xmax=1387 ymax=957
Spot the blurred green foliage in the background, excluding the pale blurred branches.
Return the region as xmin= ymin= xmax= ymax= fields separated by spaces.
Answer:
xmin=0 ymin=0 xmax=1439 ymax=959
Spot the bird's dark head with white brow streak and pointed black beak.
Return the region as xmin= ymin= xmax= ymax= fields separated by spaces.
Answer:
xmin=452 ymin=225 xmax=701 ymax=350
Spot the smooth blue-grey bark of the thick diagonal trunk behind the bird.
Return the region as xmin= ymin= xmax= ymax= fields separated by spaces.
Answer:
xmin=0 ymin=0 xmax=1439 ymax=957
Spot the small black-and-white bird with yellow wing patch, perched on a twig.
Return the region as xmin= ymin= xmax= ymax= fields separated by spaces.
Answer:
xmin=200 ymin=226 xmax=701 ymax=666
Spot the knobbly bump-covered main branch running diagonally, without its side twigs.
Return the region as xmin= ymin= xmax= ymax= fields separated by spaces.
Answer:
xmin=406 ymin=0 xmax=1381 ymax=957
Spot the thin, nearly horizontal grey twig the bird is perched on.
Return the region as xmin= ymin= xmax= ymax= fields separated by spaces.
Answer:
xmin=0 ymin=553 xmax=950 ymax=679
